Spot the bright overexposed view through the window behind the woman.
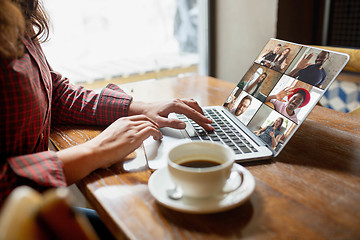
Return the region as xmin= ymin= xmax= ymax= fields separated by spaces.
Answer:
xmin=43 ymin=0 xmax=199 ymax=84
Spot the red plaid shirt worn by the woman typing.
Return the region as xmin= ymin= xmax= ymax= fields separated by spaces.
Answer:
xmin=0 ymin=32 xmax=132 ymax=203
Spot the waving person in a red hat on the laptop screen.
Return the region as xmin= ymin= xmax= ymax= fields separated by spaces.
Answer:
xmin=265 ymin=87 xmax=310 ymax=123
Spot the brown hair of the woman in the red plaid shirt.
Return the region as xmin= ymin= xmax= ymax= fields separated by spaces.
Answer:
xmin=0 ymin=0 xmax=49 ymax=59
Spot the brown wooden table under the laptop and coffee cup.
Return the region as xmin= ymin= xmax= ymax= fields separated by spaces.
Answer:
xmin=52 ymin=76 xmax=360 ymax=240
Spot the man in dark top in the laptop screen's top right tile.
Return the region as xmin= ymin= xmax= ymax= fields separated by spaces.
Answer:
xmin=289 ymin=51 xmax=330 ymax=88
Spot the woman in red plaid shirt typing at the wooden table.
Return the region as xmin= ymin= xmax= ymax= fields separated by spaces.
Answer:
xmin=0 ymin=0 xmax=213 ymax=237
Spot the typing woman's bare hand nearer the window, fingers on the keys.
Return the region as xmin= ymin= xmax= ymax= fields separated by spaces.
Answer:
xmin=128 ymin=99 xmax=214 ymax=131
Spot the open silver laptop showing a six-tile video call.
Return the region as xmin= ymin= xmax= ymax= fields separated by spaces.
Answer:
xmin=144 ymin=38 xmax=349 ymax=169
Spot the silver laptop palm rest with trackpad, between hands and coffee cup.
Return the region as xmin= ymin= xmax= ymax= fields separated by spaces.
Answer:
xmin=144 ymin=128 xmax=190 ymax=169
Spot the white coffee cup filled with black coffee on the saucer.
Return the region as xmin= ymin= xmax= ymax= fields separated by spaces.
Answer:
xmin=168 ymin=141 xmax=239 ymax=198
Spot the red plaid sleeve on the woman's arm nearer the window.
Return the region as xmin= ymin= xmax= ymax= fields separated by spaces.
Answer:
xmin=51 ymin=72 xmax=132 ymax=126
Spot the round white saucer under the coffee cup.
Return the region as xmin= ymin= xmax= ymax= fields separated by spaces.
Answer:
xmin=148 ymin=164 xmax=255 ymax=213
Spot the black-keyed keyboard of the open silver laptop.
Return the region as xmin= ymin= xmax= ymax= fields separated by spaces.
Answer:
xmin=176 ymin=109 xmax=257 ymax=154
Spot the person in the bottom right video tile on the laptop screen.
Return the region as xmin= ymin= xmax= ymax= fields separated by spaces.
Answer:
xmin=256 ymin=117 xmax=284 ymax=148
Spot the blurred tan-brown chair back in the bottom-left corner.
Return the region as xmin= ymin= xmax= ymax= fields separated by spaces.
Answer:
xmin=0 ymin=186 xmax=98 ymax=240
